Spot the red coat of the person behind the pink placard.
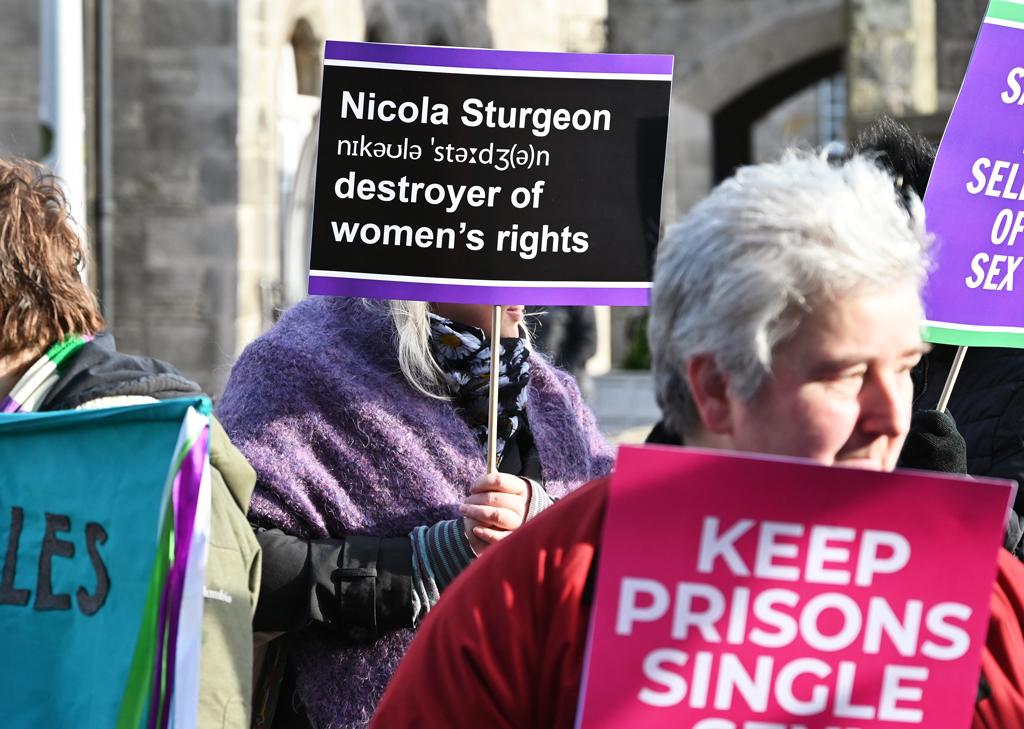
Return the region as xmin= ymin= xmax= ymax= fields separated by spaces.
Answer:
xmin=371 ymin=478 xmax=1024 ymax=729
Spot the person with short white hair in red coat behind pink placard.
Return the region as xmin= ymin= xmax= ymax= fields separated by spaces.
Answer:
xmin=374 ymin=149 xmax=1020 ymax=729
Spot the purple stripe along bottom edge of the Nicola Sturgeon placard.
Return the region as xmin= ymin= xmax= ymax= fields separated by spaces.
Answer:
xmin=309 ymin=275 xmax=650 ymax=306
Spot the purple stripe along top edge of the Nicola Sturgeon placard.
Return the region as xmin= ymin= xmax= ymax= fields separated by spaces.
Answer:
xmin=324 ymin=41 xmax=673 ymax=77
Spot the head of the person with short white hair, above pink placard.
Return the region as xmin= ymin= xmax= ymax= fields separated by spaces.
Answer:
xmin=648 ymin=150 xmax=929 ymax=470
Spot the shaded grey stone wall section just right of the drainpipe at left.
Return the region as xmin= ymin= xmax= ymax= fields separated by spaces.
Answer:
xmin=102 ymin=0 xmax=238 ymax=391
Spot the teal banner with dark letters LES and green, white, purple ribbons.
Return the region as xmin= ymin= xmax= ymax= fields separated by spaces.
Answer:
xmin=0 ymin=398 xmax=210 ymax=729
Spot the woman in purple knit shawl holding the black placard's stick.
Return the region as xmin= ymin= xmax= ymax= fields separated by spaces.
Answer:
xmin=217 ymin=298 xmax=612 ymax=729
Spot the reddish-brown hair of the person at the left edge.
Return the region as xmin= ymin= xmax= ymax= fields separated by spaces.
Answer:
xmin=0 ymin=158 xmax=103 ymax=358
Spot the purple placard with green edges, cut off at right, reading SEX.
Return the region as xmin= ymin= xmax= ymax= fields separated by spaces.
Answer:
xmin=924 ymin=0 xmax=1024 ymax=347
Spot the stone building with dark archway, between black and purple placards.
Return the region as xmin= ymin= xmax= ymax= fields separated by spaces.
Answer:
xmin=608 ymin=0 xmax=987 ymax=370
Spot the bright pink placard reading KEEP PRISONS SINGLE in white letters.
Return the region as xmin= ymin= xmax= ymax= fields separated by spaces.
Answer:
xmin=577 ymin=446 xmax=1015 ymax=729
